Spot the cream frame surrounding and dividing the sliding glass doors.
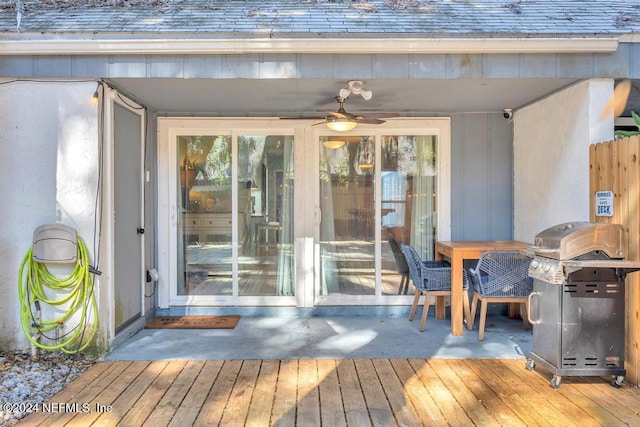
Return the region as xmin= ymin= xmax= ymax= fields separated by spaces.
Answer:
xmin=157 ymin=117 xmax=451 ymax=309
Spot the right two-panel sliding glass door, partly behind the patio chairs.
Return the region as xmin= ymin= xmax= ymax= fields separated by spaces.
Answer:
xmin=318 ymin=133 xmax=439 ymax=303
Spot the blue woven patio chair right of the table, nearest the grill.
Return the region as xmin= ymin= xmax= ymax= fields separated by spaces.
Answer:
xmin=469 ymin=251 xmax=533 ymax=341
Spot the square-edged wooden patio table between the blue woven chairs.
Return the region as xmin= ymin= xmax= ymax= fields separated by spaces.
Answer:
xmin=435 ymin=240 xmax=531 ymax=335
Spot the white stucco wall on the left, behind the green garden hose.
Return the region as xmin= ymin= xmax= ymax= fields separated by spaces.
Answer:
xmin=0 ymin=81 xmax=99 ymax=349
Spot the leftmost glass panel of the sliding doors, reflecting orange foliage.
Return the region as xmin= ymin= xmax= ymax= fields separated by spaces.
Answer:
xmin=176 ymin=135 xmax=232 ymax=296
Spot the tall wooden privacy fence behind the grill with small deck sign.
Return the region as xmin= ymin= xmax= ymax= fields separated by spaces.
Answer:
xmin=589 ymin=136 xmax=640 ymax=385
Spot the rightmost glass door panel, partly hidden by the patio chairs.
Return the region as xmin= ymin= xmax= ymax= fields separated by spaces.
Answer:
xmin=380 ymin=135 xmax=438 ymax=295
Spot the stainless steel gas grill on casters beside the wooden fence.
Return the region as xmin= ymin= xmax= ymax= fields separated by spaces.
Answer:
xmin=527 ymin=222 xmax=640 ymax=388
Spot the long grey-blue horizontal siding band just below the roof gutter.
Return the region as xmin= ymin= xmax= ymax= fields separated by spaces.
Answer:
xmin=0 ymin=43 xmax=640 ymax=80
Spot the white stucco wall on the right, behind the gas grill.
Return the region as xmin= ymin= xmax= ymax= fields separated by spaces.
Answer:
xmin=513 ymin=79 xmax=613 ymax=242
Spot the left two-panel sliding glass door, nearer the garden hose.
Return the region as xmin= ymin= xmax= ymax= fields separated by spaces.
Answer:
xmin=175 ymin=132 xmax=295 ymax=301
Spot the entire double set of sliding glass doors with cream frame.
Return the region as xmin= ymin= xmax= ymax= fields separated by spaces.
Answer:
xmin=158 ymin=119 xmax=449 ymax=308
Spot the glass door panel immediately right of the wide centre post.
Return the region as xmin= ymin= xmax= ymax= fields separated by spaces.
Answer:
xmin=319 ymin=136 xmax=376 ymax=296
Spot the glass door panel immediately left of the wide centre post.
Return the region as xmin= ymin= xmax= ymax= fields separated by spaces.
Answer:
xmin=238 ymin=135 xmax=295 ymax=296
